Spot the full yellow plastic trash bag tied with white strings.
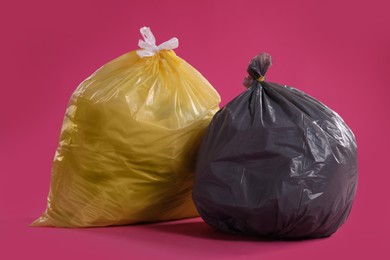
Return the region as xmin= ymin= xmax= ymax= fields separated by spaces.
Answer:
xmin=32 ymin=27 xmax=220 ymax=227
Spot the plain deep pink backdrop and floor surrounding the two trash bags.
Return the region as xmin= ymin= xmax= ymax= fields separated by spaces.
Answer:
xmin=0 ymin=0 xmax=390 ymax=260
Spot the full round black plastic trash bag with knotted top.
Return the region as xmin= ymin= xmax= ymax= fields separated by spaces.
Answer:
xmin=193 ymin=53 xmax=357 ymax=239
